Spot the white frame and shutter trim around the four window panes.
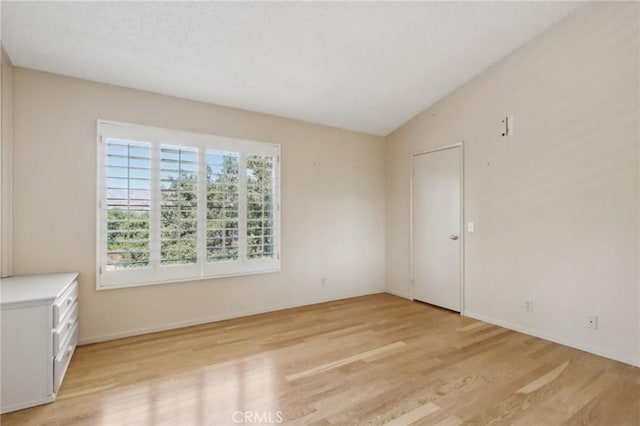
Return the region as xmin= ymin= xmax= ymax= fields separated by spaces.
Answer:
xmin=96 ymin=120 xmax=281 ymax=290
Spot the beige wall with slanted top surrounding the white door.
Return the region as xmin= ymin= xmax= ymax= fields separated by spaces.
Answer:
xmin=386 ymin=3 xmax=640 ymax=364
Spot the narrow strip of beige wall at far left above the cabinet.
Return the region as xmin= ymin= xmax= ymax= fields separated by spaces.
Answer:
xmin=0 ymin=44 xmax=13 ymax=277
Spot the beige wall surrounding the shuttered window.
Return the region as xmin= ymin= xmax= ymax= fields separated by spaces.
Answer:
xmin=13 ymin=68 xmax=385 ymax=343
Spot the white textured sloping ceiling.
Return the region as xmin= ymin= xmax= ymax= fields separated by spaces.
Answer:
xmin=2 ymin=1 xmax=582 ymax=135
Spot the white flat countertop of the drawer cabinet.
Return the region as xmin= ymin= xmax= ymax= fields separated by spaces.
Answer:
xmin=0 ymin=272 xmax=78 ymax=307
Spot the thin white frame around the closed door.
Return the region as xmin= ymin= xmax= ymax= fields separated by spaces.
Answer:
xmin=409 ymin=142 xmax=465 ymax=316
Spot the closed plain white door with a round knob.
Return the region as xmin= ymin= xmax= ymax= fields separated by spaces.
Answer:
xmin=411 ymin=146 xmax=462 ymax=312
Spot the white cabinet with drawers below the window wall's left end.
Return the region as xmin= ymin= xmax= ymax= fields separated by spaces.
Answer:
xmin=0 ymin=273 xmax=78 ymax=413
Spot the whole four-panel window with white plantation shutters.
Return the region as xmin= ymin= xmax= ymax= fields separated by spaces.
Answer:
xmin=97 ymin=120 xmax=280 ymax=289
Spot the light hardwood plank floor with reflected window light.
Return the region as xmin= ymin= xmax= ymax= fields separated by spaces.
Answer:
xmin=0 ymin=294 xmax=640 ymax=426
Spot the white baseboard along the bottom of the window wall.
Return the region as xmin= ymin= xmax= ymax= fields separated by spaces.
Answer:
xmin=78 ymin=291 xmax=384 ymax=346
